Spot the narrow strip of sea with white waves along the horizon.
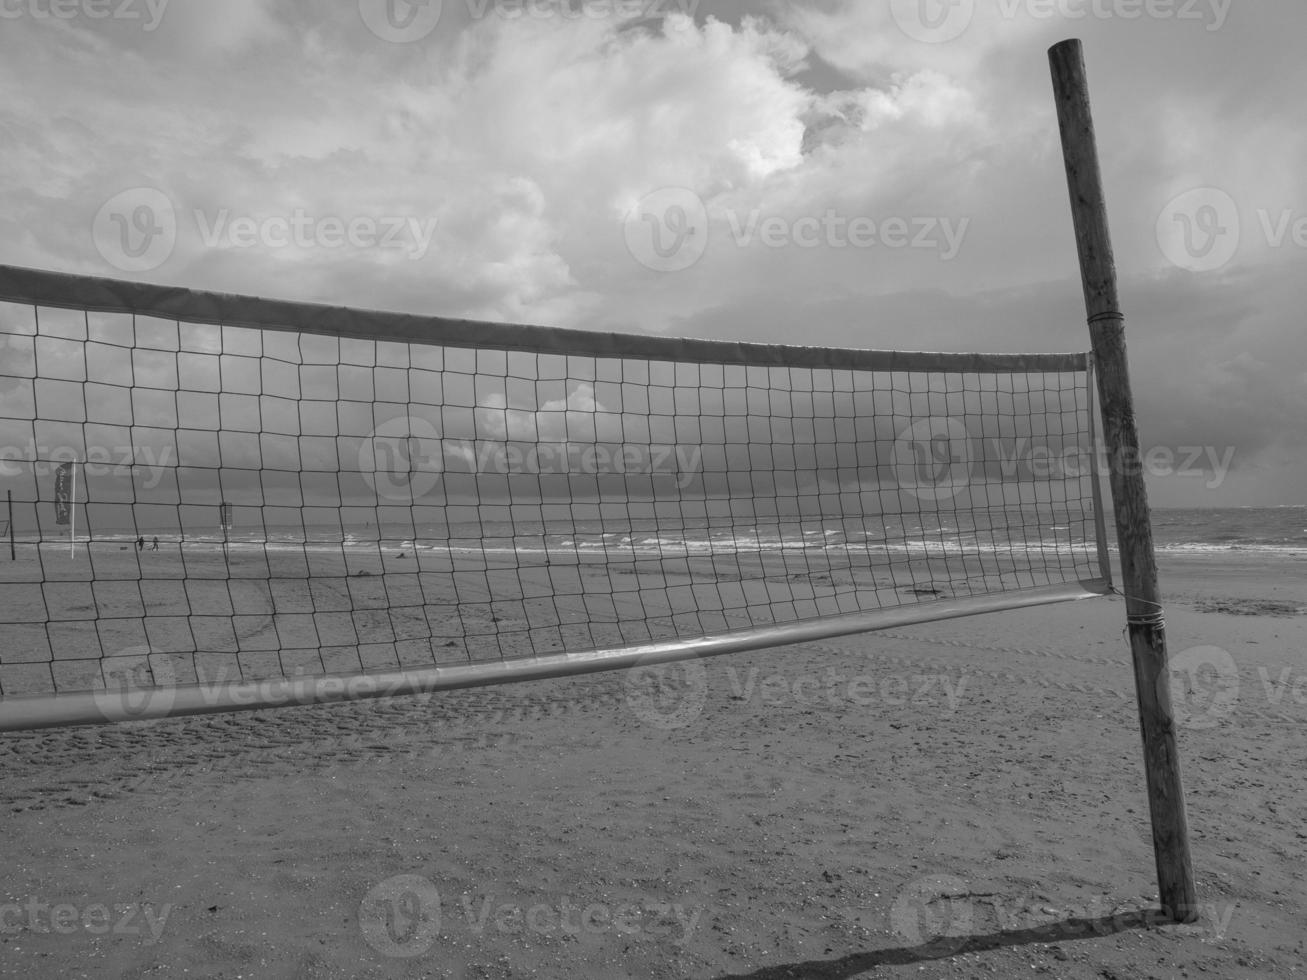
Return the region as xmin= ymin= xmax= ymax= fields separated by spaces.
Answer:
xmin=18 ymin=504 xmax=1307 ymax=558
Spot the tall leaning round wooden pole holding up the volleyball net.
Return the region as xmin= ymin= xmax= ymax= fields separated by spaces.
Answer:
xmin=1048 ymin=39 xmax=1199 ymax=923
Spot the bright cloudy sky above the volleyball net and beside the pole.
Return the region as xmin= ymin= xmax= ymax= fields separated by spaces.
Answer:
xmin=0 ymin=0 xmax=1307 ymax=506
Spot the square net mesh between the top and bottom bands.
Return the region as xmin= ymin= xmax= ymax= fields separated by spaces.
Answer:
xmin=0 ymin=265 xmax=1106 ymax=695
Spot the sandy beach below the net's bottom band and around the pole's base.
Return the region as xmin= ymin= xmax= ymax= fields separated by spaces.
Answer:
xmin=0 ymin=554 xmax=1307 ymax=980
